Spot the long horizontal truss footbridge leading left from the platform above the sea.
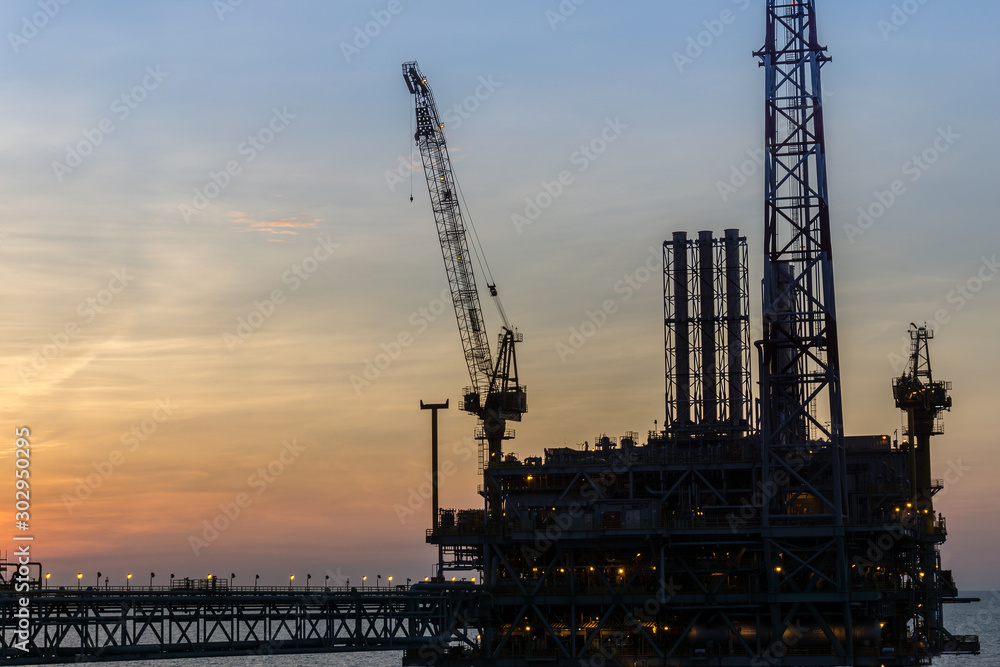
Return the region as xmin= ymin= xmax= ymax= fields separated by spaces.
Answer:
xmin=0 ymin=584 xmax=480 ymax=664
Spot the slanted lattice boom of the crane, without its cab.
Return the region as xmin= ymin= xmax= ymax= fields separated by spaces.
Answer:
xmin=403 ymin=62 xmax=493 ymax=396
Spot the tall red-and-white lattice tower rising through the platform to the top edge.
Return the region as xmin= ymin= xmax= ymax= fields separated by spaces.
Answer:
xmin=755 ymin=0 xmax=853 ymax=664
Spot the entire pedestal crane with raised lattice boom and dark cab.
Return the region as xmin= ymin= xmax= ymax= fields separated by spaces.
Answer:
xmin=403 ymin=62 xmax=527 ymax=486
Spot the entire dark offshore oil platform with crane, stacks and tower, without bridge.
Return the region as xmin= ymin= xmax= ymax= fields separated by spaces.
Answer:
xmin=403 ymin=0 xmax=979 ymax=667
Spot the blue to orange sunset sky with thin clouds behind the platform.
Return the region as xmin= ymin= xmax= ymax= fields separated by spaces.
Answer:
xmin=0 ymin=0 xmax=1000 ymax=590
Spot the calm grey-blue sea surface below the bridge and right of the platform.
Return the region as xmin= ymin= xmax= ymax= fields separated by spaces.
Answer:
xmin=103 ymin=591 xmax=1000 ymax=667
